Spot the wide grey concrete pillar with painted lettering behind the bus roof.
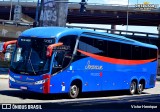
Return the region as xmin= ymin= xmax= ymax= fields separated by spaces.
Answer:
xmin=39 ymin=0 xmax=68 ymax=27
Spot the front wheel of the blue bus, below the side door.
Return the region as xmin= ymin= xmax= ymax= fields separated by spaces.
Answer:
xmin=69 ymin=84 xmax=79 ymax=98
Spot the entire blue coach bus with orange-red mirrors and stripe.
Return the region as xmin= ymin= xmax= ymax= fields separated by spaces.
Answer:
xmin=3 ymin=27 xmax=158 ymax=98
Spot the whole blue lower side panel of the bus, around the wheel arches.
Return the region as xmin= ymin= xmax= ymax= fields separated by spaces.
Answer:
xmin=50 ymin=58 xmax=157 ymax=93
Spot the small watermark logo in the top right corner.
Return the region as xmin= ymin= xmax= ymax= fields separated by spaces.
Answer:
xmin=135 ymin=2 xmax=159 ymax=11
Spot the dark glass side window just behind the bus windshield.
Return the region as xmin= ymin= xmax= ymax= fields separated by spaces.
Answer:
xmin=52 ymin=35 xmax=76 ymax=73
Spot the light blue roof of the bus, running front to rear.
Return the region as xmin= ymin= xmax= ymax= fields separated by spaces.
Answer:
xmin=20 ymin=27 xmax=158 ymax=49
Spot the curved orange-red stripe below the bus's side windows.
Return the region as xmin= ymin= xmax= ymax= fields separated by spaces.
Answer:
xmin=77 ymin=50 xmax=156 ymax=65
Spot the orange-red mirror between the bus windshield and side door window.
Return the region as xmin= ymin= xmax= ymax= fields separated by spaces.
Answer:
xmin=46 ymin=43 xmax=63 ymax=57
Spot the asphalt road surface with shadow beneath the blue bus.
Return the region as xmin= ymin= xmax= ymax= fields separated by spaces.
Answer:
xmin=0 ymin=79 xmax=160 ymax=112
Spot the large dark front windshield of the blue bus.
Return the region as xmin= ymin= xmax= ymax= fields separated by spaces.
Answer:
xmin=10 ymin=37 xmax=55 ymax=75
